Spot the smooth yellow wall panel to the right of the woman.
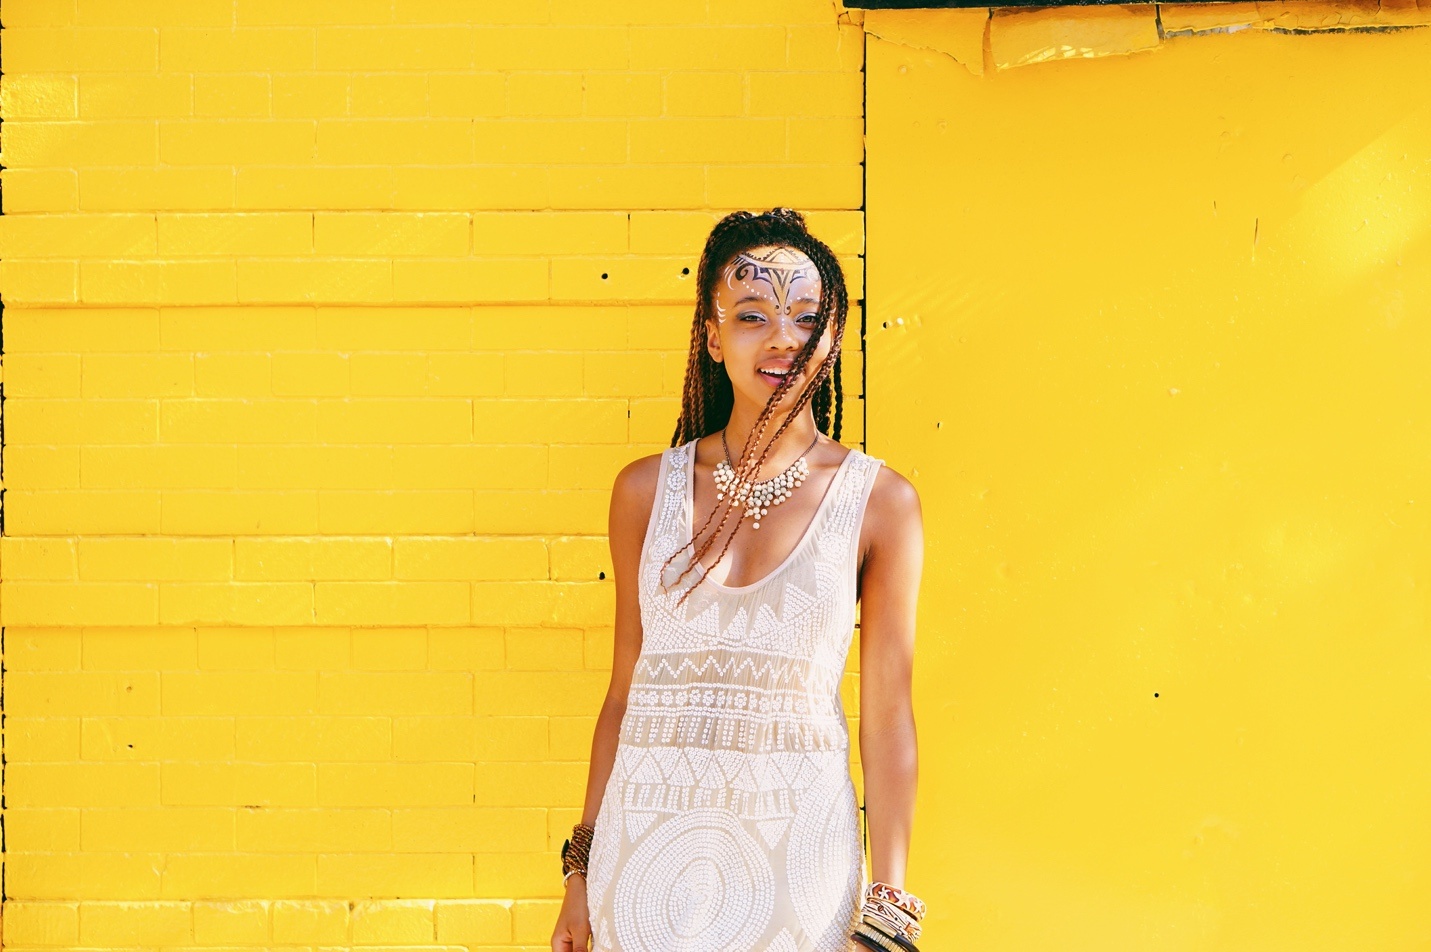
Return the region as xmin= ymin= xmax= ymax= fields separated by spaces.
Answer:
xmin=867 ymin=22 xmax=1431 ymax=951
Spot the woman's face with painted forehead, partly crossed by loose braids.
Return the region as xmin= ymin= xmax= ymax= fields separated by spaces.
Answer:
xmin=705 ymin=245 xmax=834 ymax=407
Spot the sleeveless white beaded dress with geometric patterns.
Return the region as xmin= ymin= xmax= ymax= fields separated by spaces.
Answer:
xmin=587 ymin=441 xmax=883 ymax=952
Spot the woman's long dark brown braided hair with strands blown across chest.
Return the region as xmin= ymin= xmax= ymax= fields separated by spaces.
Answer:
xmin=665 ymin=208 xmax=850 ymax=601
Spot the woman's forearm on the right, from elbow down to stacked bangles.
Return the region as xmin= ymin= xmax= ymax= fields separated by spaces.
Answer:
xmin=860 ymin=716 xmax=919 ymax=889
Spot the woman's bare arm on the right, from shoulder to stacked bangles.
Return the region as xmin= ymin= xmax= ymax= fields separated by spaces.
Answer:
xmin=860 ymin=468 xmax=924 ymax=889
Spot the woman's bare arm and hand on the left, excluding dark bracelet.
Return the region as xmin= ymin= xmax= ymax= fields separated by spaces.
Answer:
xmin=551 ymin=457 xmax=661 ymax=952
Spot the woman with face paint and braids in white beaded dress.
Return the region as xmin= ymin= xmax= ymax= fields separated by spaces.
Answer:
xmin=552 ymin=209 xmax=923 ymax=952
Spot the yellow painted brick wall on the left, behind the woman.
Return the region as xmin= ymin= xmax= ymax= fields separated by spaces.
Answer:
xmin=0 ymin=0 xmax=863 ymax=951
